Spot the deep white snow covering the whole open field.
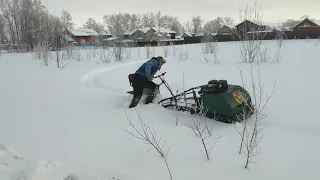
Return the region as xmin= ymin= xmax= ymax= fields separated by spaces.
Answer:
xmin=0 ymin=40 xmax=320 ymax=180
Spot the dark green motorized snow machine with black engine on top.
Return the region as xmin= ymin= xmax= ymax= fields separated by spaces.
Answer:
xmin=128 ymin=72 xmax=254 ymax=123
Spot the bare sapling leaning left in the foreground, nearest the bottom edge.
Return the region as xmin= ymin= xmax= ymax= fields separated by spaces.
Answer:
xmin=124 ymin=110 xmax=172 ymax=180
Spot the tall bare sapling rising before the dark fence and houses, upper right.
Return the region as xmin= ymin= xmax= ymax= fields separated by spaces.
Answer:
xmin=236 ymin=3 xmax=267 ymax=63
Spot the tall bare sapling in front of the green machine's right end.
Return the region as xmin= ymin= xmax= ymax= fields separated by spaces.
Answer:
xmin=237 ymin=65 xmax=275 ymax=168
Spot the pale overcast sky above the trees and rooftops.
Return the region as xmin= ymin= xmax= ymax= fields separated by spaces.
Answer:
xmin=42 ymin=0 xmax=320 ymax=26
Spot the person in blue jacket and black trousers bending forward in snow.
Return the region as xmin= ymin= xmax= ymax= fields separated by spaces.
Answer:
xmin=129 ymin=56 xmax=166 ymax=108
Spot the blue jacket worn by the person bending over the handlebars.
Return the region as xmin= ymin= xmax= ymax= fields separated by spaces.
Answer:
xmin=136 ymin=58 xmax=160 ymax=78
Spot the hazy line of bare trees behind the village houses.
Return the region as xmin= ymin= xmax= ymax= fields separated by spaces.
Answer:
xmin=0 ymin=0 xmax=310 ymax=50
